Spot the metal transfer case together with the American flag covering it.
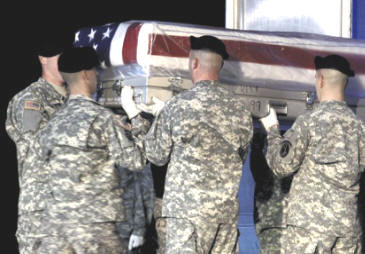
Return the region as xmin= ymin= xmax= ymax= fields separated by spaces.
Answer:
xmin=75 ymin=20 xmax=365 ymax=121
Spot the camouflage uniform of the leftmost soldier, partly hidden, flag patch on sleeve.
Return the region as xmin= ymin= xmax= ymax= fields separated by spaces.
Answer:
xmin=5 ymin=78 xmax=66 ymax=253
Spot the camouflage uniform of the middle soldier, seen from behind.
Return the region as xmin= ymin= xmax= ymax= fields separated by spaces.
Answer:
xmin=146 ymin=81 xmax=253 ymax=254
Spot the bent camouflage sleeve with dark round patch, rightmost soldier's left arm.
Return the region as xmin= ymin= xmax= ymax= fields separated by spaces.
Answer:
xmin=266 ymin=116 xmax=308 ymax=177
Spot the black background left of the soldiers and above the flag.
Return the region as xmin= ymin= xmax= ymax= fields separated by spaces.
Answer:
xmin=0 ymin=0 xmax=225 ymax=254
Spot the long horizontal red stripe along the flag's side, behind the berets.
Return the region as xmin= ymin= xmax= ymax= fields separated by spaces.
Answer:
xmin=149 ymin=34 xmax=365 ymax=74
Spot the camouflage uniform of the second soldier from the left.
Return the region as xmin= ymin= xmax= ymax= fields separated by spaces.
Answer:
xmin=33 ymin=95 xmax=149 ymax=254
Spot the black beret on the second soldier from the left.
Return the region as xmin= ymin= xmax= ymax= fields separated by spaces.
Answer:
xmin=58 ymin=47 xmax=100 ymax=73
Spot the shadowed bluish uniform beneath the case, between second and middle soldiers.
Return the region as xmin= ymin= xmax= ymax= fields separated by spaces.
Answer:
xmin=117 ymin=164 xmax=155 ymax=248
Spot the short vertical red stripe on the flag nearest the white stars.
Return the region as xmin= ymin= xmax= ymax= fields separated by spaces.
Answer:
xmin=122 ymin=23 xmax=142 ymax=64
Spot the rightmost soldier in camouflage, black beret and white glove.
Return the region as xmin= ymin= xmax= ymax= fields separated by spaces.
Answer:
xmin=261 ymin=55 xmax=365 ymax=254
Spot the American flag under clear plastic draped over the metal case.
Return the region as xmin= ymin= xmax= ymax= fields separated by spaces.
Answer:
xmin=75 ymin=20 xmax=365 ymax=98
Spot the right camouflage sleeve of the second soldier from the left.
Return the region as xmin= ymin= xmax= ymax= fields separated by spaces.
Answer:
xmin=106 ymin=115 xmax=146 ymax=171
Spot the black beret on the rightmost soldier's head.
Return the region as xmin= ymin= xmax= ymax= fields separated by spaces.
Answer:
xmin=314 ymin=55 xmax=355 ymax=77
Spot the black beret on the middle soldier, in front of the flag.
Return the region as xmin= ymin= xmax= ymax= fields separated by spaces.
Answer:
xmin=190 ymin=35 xmax=229 ymax=59
